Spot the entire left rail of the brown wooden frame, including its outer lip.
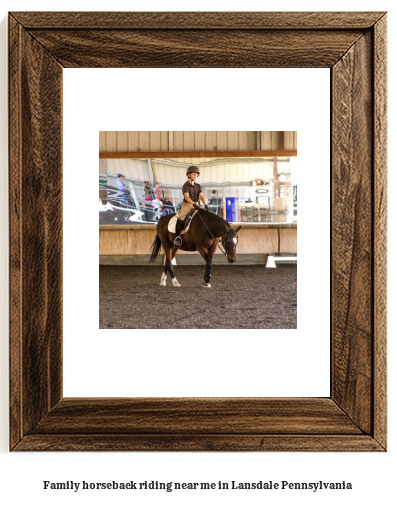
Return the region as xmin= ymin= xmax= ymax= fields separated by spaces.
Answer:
xmin=10 ymin=15 xmax=62 ymax=448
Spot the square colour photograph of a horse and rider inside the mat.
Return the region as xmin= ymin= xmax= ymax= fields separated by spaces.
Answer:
xmin=99 ymin=131 xmax=298 ymax=329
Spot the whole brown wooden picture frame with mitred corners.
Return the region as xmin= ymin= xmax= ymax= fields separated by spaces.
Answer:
xmin=9 ymin=12 xmax=386 ymax=451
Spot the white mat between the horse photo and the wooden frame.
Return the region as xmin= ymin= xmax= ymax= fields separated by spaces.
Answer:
xmin=63 ymin=69 xmax=330 ymax=397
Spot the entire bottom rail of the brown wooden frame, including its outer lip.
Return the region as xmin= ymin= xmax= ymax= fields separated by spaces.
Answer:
xmin=16 ymin=398 xmax=380 ymax=451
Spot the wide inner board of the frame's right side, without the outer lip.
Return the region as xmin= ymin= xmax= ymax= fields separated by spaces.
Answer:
xmin=331 ymin=33 xmax=373 ymax=433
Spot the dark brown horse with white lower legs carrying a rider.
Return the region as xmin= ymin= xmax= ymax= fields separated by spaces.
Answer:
xmin=149 ymin=209 xmax=241 ymax=287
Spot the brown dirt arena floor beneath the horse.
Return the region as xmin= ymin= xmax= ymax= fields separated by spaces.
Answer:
xmin=99 ymin=264 xmax=297 ymax=329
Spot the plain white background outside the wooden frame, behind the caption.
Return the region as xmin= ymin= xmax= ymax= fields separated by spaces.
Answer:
xmin=0 ymin=0 xmax=397 ymax=507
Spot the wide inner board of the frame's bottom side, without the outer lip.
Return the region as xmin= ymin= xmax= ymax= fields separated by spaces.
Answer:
xmin=32 ymin=398 xmax=362 ymax=435
